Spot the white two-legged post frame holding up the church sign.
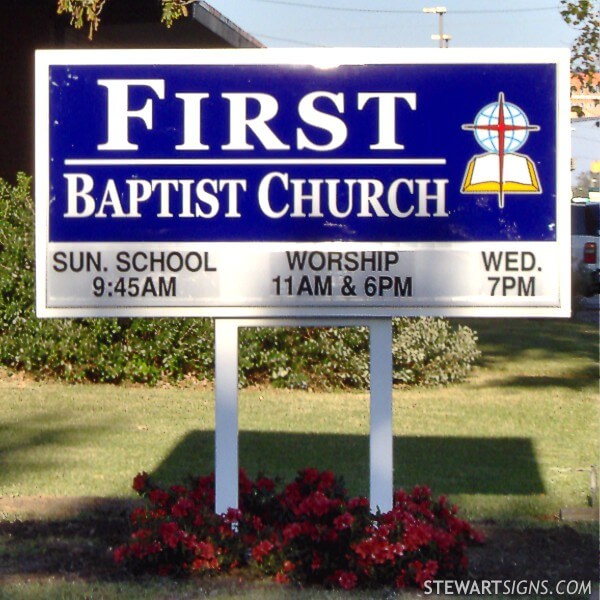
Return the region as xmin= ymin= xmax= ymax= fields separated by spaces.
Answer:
xmin=215 ymin=318 xmax=394 ymax=513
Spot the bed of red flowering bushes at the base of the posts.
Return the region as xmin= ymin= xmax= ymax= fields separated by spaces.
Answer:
xmin=114 ymin=469 xmax=482 ymax=589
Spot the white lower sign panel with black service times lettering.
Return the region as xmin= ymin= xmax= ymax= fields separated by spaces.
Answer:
xmin=46 ymin=243 xmax=564 ymax=317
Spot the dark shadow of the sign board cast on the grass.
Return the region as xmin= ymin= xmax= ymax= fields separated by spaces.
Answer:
xmin=152 ymin=431 xmax=545 ymax=496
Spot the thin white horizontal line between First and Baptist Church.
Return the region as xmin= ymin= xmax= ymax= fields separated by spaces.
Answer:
xmin=65 ymin=158 xmax=446 ymax=167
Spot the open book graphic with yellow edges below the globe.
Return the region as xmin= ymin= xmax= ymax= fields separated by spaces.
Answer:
xmin=462 ymin=153 xmax=541 ymax=194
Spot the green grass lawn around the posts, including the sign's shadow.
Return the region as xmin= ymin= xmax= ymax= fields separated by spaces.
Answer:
xmin=0 ymin=320 xmax=599 ymax=522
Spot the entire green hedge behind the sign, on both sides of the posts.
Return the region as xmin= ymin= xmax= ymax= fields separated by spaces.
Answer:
xmin=0 ymin=174 xmax=479 ymax=389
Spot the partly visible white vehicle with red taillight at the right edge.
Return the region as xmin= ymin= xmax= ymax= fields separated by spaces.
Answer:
xmin=571 ymin=202 xmax=600 ymax=298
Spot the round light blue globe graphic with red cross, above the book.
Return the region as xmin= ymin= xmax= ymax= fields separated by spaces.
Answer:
xmin=474 ymin=102 xmax=529 ymax=153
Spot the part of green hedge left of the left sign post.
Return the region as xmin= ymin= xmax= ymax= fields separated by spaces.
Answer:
xmin=0 ymin=174 xmax=214 ymax=383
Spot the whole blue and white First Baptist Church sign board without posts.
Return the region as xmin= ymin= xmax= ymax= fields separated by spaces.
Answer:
xmin=36 ymin=49 xmax=570 ymax=317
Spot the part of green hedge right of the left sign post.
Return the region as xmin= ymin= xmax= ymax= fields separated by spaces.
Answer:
xmin=240 ymin=318 xmax=479 ymax=389
